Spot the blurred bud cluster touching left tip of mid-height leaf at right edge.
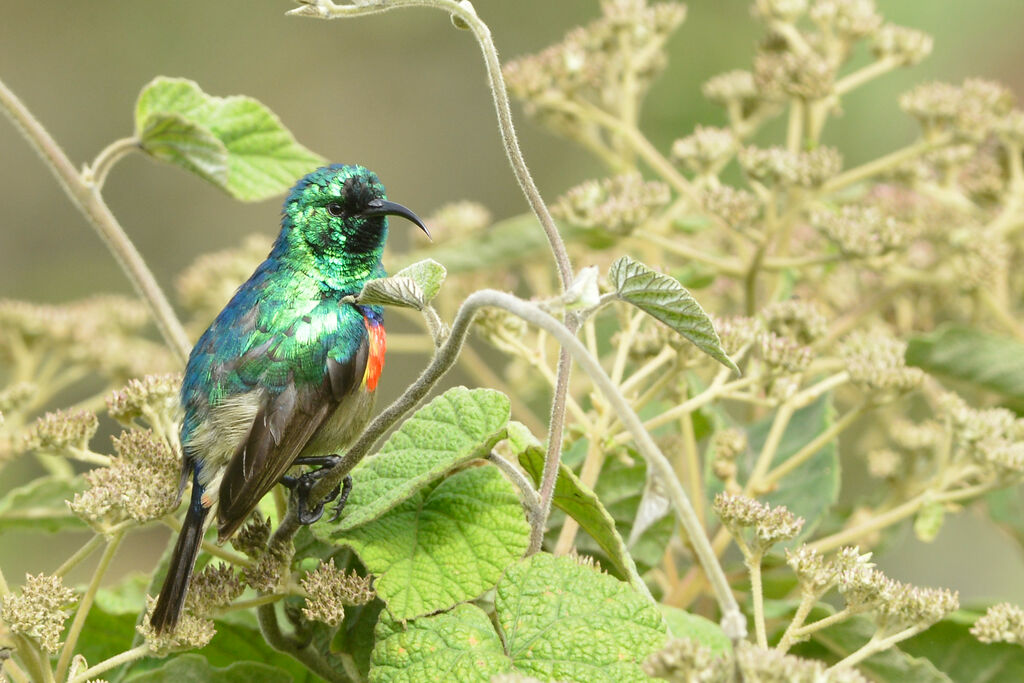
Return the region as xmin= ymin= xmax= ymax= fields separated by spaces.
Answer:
xmin=840 ymin=331 xmax=925 ymax=398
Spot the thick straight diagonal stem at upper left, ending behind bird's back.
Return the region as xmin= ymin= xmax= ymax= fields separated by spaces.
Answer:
xmin=0 ymin=76 xmax=191 ymax=364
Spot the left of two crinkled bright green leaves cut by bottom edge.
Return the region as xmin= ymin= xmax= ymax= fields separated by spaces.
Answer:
xmin=370 ymin=605 xmax=512 ymax=683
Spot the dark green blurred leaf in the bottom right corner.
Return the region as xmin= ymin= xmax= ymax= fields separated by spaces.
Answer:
xmin=900 ymin=609 xmax=1024 ymax=683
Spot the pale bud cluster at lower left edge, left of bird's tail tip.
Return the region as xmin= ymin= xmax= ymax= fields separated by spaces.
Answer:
xmin=0 ymin=573 xmax=76 ymax=654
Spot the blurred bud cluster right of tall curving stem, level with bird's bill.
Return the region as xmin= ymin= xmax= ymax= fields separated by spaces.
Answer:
xmin=551 ymin=173 xmax=672 ymax=236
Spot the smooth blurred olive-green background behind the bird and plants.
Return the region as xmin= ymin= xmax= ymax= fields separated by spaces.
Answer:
xmin=0 ymin=0 xmax=1024 ymax=602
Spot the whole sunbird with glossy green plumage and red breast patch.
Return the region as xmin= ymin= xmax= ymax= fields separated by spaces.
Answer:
xmin=150 ymin=164 xmax=429 ymax=633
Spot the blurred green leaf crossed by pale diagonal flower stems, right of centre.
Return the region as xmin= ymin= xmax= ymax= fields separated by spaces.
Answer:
xmin=706 ymin=394 xmax=840 ymax=548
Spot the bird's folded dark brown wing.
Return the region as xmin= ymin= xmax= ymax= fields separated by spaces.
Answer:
xmin=217 ymin=336 xmax=370 ymax=541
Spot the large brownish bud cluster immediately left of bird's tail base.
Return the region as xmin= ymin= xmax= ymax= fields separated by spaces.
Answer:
xmin=69 ymin=430 xmax=181 ymax=525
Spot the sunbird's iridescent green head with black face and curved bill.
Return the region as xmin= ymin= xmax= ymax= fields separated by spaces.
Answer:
xmin=281 ymin=164 xmax=429 ymax=282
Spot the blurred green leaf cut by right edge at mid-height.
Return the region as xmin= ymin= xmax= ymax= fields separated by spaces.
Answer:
xmin=906 ymin=325 xmax=1024 ymax=402
